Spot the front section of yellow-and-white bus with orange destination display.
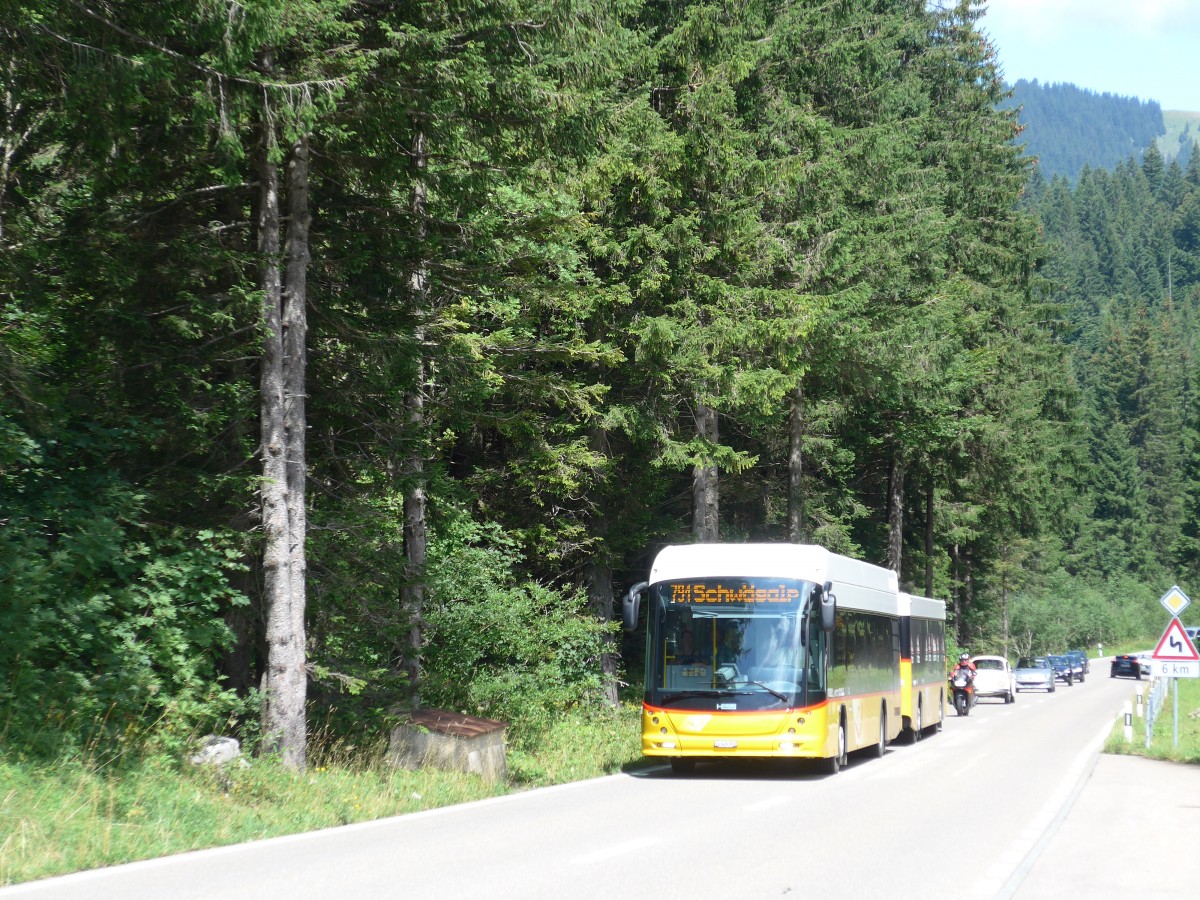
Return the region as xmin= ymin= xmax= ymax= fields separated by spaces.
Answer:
xmin=624 ymin=544 xmax=907 ymax=773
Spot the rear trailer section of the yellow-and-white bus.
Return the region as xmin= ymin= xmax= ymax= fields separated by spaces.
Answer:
xmin=900 ymin=593 xmax=946 ymax=742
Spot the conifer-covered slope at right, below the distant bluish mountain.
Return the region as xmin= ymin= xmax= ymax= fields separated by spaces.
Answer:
xmin=1030 ymin=146 xmax=1200 ymax=600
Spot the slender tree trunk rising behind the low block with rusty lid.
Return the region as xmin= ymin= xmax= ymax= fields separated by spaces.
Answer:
xmin=401 ymin=132 xmax=430 ymax=709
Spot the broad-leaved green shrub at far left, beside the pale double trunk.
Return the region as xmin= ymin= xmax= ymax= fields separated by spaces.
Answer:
xmin=0 ymin=436 xmax=246 ymax=752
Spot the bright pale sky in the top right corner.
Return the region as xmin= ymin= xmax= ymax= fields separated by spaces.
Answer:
xmin=978 ymin=0 xmax=1200 ymax=112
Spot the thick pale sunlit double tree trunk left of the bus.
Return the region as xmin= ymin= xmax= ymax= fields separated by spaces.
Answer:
xmin=258 ymin=70 xmax=307 ymax=769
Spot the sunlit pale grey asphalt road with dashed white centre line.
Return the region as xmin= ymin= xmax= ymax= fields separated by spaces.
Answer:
xmin=0 ymin=664 xmax=1200 ymax=900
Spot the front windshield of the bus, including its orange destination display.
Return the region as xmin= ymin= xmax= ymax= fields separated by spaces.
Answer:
xmin=647 ymin=577 xmax=823 ymax=709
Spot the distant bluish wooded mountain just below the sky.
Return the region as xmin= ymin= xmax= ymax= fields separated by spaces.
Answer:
xmin=1004 ymin=78 xmax=1166 ymax=182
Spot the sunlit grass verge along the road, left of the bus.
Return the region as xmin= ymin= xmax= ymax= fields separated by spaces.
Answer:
xmin=0 ymin=706 xmax=641 ymax=884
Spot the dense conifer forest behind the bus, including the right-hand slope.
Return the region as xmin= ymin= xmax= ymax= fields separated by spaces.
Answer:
xmin=0 ymin=0 xmax=1200 ymax=767
